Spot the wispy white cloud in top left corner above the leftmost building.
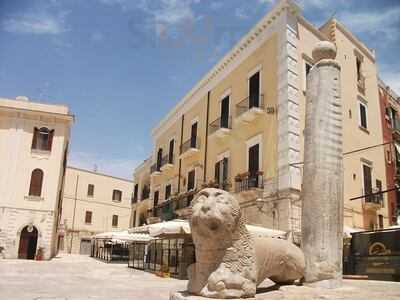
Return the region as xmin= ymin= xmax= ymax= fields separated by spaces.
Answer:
xmin=2 ymin=11 xmax=69 ymax=35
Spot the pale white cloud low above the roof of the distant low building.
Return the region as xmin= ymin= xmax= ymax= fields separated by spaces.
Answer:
xmin=68 ymin=152 xmax=142 ymax=180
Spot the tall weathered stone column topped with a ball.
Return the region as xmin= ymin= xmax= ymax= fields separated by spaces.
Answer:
xmin=301 ymin=41 xmax=343 ymax=288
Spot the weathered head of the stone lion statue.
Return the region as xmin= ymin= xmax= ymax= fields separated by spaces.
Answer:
xmin=190 ymin=188 xmax=241 ymax=248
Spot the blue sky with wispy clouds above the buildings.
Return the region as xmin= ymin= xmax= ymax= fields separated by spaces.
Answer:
xmin=0 ymin=0 xmax=400 ymax=178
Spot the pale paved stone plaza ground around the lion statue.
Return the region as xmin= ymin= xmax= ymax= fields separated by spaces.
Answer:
xmin=0 ymin=256 xmax=400 ymax=300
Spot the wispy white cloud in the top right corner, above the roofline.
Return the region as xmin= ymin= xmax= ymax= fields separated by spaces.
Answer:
xmin=337 ymin=7 xmax=400 ymax=40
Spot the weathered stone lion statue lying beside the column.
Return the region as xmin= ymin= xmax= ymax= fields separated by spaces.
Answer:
xmin=188 ymin=188 xmax=305 ymax=299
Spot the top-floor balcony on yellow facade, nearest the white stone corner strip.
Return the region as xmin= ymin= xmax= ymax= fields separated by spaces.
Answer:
xmin=235 ymin=95 xmax=266 ymax=123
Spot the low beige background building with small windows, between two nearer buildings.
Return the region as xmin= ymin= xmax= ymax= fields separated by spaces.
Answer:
xmin=58 ymin=166 xmax=133 ymax=254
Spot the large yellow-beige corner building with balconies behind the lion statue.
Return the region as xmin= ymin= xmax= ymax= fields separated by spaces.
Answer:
xmin=133 ymin=0 xmax=388 ymax=233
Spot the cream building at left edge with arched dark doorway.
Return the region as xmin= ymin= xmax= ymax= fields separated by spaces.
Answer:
xmin=0 ymin=97 xmax=74 ymax=259
